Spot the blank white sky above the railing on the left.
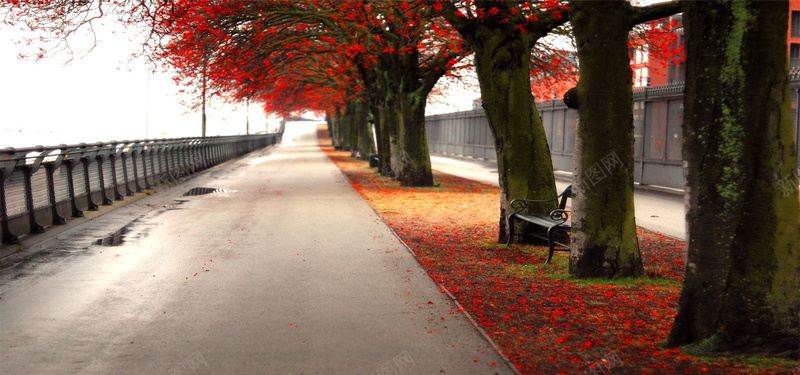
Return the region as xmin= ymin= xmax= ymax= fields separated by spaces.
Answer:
xmin=0 ymin=19 xmax=276 ymax=148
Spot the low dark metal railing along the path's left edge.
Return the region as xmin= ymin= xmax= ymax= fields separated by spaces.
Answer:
xmin=0 ymin=133 xmax=281 ymax=248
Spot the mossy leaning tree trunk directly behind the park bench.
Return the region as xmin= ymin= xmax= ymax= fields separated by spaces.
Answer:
xmin=471 ymin=26 xmax=557 ymax=242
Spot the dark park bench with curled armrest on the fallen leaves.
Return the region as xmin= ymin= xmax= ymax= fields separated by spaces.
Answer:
xmin=506 ymin=185 xmax=572 ymax=264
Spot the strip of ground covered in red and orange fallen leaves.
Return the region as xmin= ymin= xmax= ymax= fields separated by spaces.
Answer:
xmin=320 ymin=131 xmax=798 ymax=375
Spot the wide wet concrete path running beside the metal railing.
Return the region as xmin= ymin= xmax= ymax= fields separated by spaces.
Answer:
xmin=0 ymin=123 xmax=513 ymax=374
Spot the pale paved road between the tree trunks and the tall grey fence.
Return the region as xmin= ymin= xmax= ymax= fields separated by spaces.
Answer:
xmin=431 ymin=155 xmax=686 ymax=240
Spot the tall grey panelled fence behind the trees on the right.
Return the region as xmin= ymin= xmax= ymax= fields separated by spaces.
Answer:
xmin=425 ymin=79 xmax=800 ymax=189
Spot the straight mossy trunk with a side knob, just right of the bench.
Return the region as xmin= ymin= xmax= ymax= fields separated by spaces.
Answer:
xmin=566 ymin=0 xmax=644 ymax=278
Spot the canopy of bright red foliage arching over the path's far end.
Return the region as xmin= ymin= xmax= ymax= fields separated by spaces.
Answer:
xmin=151 ymin=0 xmax=464 ymax=114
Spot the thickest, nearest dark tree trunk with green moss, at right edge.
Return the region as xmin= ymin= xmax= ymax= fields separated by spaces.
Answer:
xmin=668 ymin=1 xmax=800 ymax=357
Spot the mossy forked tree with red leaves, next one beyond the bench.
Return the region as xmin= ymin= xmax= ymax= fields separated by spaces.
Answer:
xmin=345 ymin=1 xmax=467 ymax=186
